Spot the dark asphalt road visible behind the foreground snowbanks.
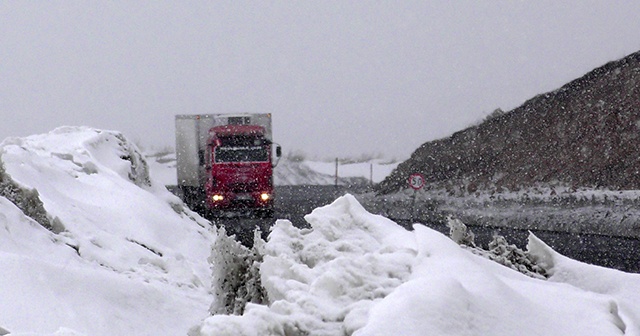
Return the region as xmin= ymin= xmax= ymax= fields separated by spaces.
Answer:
xmin=211 ymin=186 xmax=640 ymax=273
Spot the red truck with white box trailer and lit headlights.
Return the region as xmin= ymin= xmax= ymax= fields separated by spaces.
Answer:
xmin=176 ymin=114 xmax=282 ymax=218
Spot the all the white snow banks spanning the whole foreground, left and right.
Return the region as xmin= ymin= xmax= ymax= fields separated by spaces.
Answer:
xmin=0 ymin=127 xmax=640 ymax=336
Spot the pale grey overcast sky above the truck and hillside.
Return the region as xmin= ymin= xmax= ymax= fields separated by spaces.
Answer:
xmin=0 ymin=0 xmax=640 ymax=158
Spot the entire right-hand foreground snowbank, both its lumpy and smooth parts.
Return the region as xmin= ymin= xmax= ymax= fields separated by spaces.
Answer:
xmin=193 ymin=195 xmax=640 ymax=335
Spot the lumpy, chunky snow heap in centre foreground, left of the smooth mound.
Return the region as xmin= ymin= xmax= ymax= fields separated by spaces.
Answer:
xmin=198 ymin=195 xmax=416 ymax=335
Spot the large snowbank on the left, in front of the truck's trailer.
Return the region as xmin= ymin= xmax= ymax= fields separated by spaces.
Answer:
xmin=0 ymin=127 xmax=212 ymax=335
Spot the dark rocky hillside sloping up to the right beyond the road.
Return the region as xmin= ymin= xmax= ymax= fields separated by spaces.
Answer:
xmin=378 ymin=52 xmax=640 ymax=193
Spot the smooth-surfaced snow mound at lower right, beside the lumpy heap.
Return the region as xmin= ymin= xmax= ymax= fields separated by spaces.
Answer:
xmin=354 ymin=226 xmax=621 ymax=335
